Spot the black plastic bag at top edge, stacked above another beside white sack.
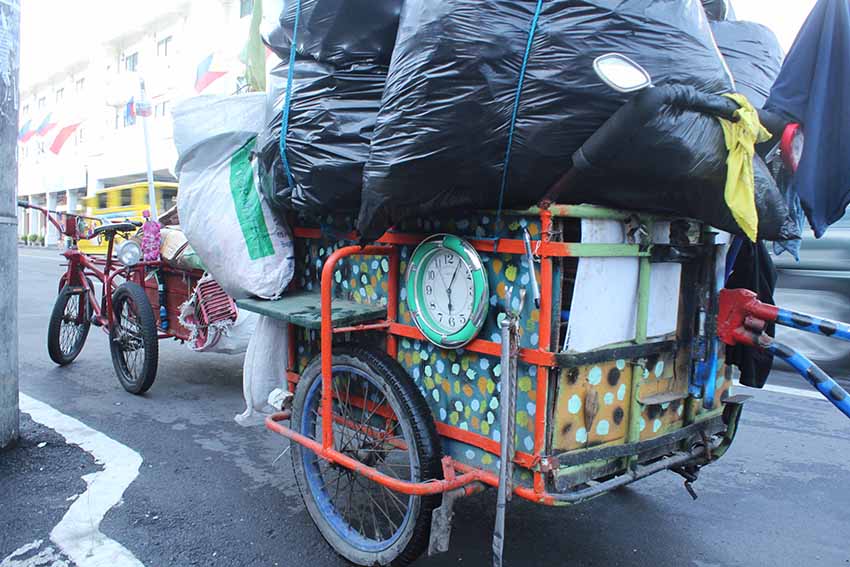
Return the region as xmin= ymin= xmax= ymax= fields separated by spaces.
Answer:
xmin=269 ymin=0 xmax=403 ymax=67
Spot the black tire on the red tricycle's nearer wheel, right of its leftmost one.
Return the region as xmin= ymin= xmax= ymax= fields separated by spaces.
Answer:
xmin=109 ymin=282 xmax=159 ymax=395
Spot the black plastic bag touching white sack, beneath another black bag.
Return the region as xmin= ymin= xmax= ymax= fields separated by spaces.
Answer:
xmin=257 ymin=59 xmax=386 ymax=214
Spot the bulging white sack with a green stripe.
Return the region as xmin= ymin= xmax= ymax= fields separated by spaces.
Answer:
xmin=173 ymin=93 xmax=294 ymax=299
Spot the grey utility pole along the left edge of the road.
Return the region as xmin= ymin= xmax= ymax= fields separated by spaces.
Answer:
xmin=0 ymin=0 xmax=21 ymax=449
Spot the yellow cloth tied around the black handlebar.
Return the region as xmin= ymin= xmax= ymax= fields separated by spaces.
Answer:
xmin=720 ymin=94 xmax=771 ymax=242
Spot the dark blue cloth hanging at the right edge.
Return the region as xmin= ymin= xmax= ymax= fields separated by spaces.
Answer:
xmin=767 ymin=0 xmax=850 ymax=238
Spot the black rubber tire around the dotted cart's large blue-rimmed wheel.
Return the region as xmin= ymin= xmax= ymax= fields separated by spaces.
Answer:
xmin=291 ymin=346 xmax=443 ymax=567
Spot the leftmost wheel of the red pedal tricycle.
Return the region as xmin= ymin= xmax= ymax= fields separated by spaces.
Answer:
xmin=47 ymin=286 xmax=91 ymax=366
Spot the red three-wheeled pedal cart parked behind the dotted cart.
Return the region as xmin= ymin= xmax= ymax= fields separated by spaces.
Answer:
xmin=18 ymin=201 xmax=237 ymax=394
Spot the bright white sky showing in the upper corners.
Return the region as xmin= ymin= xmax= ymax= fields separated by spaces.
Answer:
xmin=21 ymin=0 xmax=815 ymax=88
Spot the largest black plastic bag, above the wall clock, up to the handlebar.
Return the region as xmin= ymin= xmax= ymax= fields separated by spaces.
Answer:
xmin=358 ymin=0 xmax=731 ymax=238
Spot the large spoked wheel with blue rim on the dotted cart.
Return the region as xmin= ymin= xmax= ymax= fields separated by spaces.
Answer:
xmin=292 ymin=347 xmax=442 ymax=566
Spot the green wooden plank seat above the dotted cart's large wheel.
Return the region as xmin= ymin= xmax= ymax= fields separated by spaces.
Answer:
xmin=236 ymin=291 xmax=387 ymax=329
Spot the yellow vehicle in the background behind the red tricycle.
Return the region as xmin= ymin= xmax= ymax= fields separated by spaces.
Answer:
xmin=78 ymin=182 xmax=177 ymax=254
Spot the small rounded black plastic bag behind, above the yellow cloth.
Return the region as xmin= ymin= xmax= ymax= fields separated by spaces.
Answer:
xmin=711 ymin=21 xmax=785 ymax=108
